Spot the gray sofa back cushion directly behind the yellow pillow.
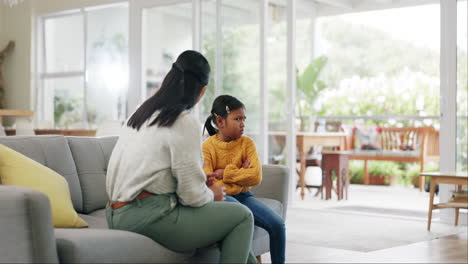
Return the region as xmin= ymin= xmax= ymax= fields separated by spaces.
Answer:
xmin=0 ymin=135 xmax=83 ymax=212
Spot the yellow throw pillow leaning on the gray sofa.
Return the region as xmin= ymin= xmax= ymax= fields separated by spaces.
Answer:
xmin=0 ymin=144 xmax=88 ymax=227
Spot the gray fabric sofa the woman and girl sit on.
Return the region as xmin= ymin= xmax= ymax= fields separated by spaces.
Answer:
xmin=0 ymin=135 xmax=288 ymax=263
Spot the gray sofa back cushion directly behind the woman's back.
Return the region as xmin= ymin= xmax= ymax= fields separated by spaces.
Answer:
xmin=67 ymin=137 xmax=118 ymax=214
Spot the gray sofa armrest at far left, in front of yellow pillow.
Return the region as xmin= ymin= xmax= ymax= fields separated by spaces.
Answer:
xmin=0 ymin=185 xmax=58 ymax=263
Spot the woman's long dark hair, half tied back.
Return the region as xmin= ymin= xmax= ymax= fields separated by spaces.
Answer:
xmin=127 ymin=50 xmax=210 ymax=130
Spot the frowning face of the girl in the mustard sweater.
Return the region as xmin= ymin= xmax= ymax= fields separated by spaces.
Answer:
xmin=217 ymin=108 xmax=246 ymax=140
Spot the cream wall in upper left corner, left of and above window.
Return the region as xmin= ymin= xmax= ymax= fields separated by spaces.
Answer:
xmin=0 ymin=0 xmax=122 ymax=125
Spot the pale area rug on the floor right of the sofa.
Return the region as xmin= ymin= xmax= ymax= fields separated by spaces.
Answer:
xmin=286 ymin=208 xmax=467 ymax=252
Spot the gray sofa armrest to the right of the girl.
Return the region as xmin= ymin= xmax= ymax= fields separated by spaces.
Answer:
xmin=252 ymin=165 xmax=289 ymax=219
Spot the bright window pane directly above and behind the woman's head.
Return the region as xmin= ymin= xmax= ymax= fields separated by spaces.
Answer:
xmin=142 ymin=3 xmax=192 ymax=97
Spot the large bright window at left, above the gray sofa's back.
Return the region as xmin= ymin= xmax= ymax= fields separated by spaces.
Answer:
xmin=38 ymin=4 xmax=128 ymax=128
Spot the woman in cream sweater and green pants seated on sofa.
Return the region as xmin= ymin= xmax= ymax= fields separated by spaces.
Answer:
xmin=106 ymin=51 xmax=256 ymax=263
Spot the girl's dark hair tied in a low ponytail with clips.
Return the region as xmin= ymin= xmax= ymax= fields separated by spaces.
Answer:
xmin=203 ymin=95 xmax=245 ymax=136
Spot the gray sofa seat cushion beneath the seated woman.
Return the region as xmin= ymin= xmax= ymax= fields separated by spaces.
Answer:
xmin=55 ymin=228 xmax=191 ymax=263
